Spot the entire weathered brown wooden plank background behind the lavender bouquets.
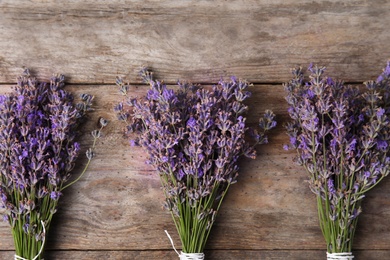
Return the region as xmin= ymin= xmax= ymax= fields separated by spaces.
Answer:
xmin=0 ymin=0 xmax=390 ymax=260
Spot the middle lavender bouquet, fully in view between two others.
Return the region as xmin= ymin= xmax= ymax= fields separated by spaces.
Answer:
xmin=115 ymin=69 xmax=276 ymax=259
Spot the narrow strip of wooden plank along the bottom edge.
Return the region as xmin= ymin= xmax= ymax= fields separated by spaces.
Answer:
xmin=0 ymin=250 xmax=390 ymax=260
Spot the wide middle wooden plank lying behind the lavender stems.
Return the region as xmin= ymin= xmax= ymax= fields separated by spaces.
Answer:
xmin=0 ymin=85 xmax=390 ymax=255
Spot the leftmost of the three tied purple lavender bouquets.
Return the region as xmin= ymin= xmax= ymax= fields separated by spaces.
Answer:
xmin=0 ymin=71 xmax=106 ymax=259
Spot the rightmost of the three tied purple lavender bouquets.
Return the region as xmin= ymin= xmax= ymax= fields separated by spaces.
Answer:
xmin=285 ymin=62 xmax=390 ymax=259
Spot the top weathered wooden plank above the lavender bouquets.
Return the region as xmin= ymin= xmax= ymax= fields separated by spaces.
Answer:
xmin=0 ymin=0 xmax=390 ymax=83
